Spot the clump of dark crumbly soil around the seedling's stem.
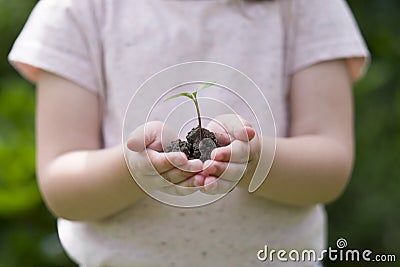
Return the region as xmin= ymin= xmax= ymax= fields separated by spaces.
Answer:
xmin=165 ymin=126 xmax=220 ymax=162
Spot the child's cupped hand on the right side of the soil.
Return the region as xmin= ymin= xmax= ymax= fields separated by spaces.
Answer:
xmin=197 ymin=114 xmax=261 ymax=194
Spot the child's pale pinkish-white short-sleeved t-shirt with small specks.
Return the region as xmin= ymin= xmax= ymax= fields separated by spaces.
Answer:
xmin=9 ymin=0 xmax=368 ymax=267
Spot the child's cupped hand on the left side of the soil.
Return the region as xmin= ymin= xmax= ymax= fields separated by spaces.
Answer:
xmin=126 ymin=121 xmax=204 ymax=195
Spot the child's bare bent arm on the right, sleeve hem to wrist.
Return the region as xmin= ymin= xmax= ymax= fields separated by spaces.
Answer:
xmin=244 ymin=60 xmax=354 ymax=205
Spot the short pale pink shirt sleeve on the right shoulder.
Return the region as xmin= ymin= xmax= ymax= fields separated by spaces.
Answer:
xmin=284 ymin=0 xmax=369 ymax=81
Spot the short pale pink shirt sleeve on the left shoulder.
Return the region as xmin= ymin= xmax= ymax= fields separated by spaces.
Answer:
xmin=8 ymin=0 xmax=103 ymax=93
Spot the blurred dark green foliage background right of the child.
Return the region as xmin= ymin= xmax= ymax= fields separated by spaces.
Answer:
xmin=327 ymin=0 xmax=400 ymax=266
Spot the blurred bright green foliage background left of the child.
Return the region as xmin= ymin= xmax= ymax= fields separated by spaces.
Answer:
xmin=0 ymin=0 xmax=76 ymax=267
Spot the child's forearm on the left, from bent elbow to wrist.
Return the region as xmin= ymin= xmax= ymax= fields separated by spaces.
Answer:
xmin=38 ymin=146 xmax=144 ymax=221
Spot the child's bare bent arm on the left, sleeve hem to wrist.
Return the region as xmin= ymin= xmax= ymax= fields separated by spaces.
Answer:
xmin=36 ymin=72 xmax=144 ymax=220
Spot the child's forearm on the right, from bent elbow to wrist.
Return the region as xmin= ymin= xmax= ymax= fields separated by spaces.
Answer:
xmin=241 ymin=135 xmax=353 ymax=206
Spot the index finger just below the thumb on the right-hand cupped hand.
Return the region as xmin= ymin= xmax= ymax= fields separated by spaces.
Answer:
xmin=211 ymin=140 xmax=250 ymax=163
